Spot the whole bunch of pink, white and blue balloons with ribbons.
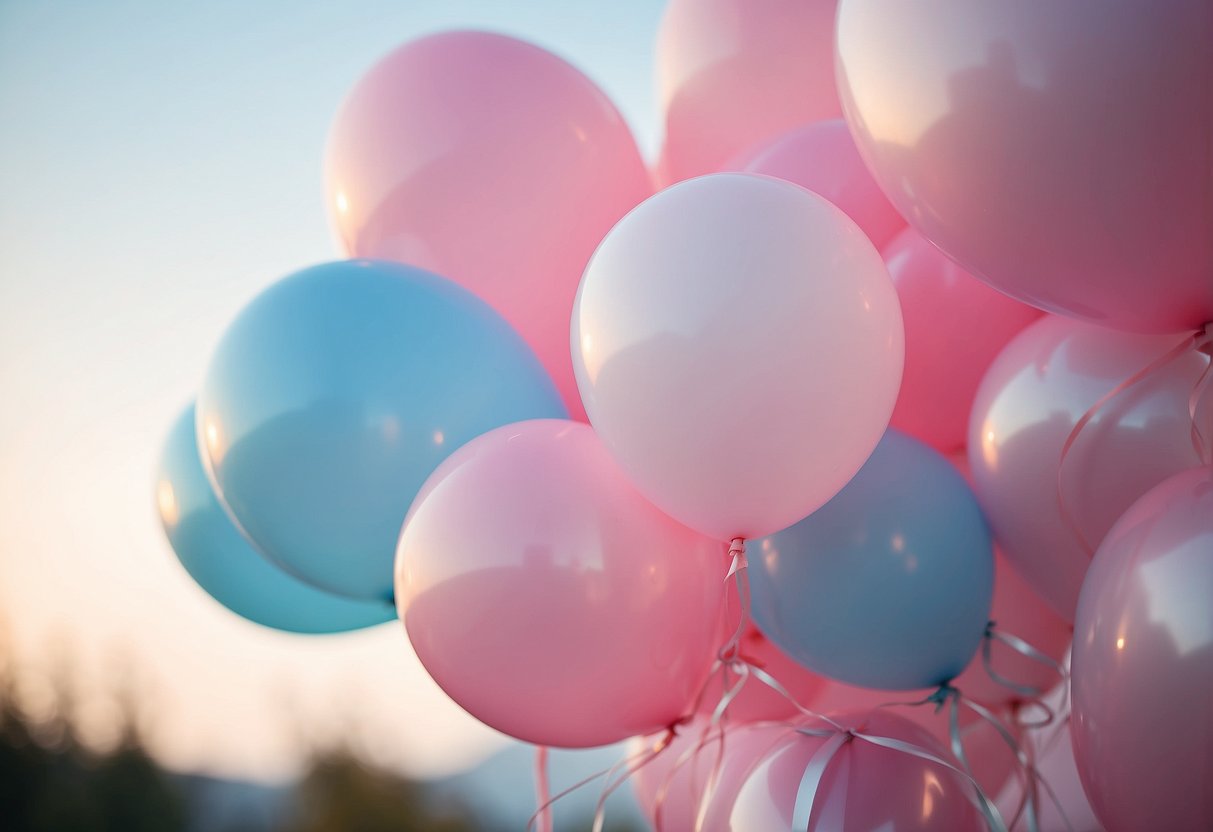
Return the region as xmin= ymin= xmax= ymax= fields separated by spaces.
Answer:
xmin=158 ymin=0 xmax=1213 ymax=831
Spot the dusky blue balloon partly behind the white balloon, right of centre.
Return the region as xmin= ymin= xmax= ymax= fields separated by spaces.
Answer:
xmin=747 ymin=431 xmax=993 ymax=690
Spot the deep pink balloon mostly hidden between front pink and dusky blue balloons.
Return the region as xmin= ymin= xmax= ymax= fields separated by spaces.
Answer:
xmin=699 ymin=625 xmax=827 ymax=723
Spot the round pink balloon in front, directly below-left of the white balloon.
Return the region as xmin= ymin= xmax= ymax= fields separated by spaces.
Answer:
xmin=395 ymin=420 xmax=727 ymax=747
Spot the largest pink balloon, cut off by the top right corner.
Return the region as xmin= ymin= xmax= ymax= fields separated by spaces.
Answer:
xmin=838 ymin=0 xmax=1213 ymax=332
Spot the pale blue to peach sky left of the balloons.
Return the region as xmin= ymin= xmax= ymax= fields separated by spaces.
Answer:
xmin=0 ymin=0 xmax=662 ymax=780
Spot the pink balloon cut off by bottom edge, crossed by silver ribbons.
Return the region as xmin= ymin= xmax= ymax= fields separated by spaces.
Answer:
xmin=730 ymin=711 xmax=985 ymax=832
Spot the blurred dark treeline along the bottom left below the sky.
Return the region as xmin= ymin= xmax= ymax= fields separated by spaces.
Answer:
xmin=0 ymin=630 xmax=632 ymax=832
